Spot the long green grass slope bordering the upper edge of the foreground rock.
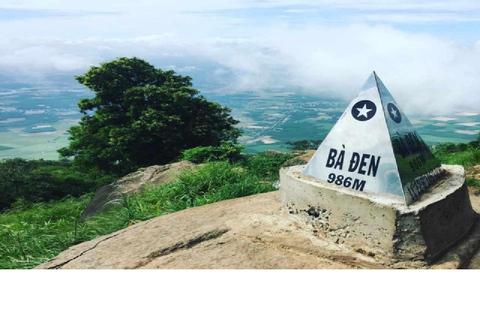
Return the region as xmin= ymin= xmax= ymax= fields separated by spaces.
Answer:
xmin=0 ymin=159 xmax=283 ymax=269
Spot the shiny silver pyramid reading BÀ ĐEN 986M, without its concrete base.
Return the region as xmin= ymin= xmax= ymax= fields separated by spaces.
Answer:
xmin=303 ymin=72 xmax=443 ymax=205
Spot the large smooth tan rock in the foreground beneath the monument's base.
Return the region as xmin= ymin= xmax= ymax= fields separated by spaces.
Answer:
xmin=38 ymin=191 xmax=480 ymax=269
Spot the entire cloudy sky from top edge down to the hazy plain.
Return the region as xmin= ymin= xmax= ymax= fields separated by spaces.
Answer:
xmin=0 ymin=0 xmax=480 ymax=114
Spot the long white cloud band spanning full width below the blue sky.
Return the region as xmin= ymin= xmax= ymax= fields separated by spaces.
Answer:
xmin=0 ymin=25 xmax=480 ymax=113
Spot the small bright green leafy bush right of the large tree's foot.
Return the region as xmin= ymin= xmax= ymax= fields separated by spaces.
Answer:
xmin=183 ymin=142 xmax=245 ymax=163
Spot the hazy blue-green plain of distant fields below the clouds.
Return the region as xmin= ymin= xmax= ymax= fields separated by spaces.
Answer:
xmin=0 ymin=80 xmax=480 ymax=160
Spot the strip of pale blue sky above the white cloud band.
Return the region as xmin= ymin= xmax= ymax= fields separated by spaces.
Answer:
xmin=0 ymin=0 xmax=480 ymax=41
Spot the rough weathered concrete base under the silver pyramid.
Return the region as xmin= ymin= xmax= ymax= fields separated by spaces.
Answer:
xmin=280 ymin=166 xmax=478 ymax=263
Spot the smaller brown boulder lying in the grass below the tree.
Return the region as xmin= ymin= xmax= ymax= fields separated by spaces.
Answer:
xmin=81 ymin=161 xmax=195 ymax=219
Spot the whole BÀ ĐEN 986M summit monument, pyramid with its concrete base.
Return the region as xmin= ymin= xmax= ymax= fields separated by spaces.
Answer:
xmin=280 ymin=72 xmax=478 ymax=264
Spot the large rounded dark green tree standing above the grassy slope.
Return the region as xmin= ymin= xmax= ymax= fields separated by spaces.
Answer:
xmin=59 ymin=58 xmax=240 ymax=174
